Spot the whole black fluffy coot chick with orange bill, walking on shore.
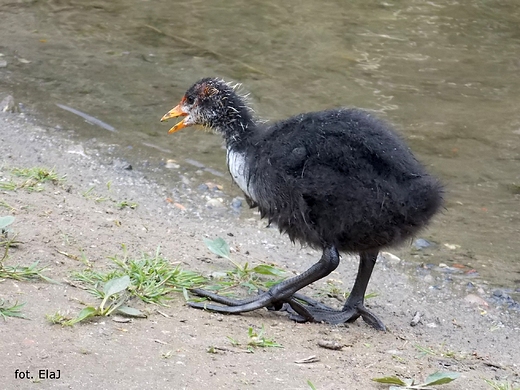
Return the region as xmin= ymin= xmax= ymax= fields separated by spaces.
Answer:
xmin=161 ymin=78 xmax=442 ymax=330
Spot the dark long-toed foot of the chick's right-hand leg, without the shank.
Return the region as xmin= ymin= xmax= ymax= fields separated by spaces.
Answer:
xmin=281 ymin=294 xmax=386 ymax=331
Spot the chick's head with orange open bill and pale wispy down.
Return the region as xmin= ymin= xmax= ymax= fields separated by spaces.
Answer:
xmin=161 ymin=78 xmax=251 ymax=135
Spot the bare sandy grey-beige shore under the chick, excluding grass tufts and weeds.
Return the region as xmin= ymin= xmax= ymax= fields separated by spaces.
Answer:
xmin=0 ymin=108 xmax=520 ymax=390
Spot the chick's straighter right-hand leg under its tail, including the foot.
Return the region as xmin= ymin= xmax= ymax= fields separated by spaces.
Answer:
xmin=280 ymin=251 xmax=386 ymax=330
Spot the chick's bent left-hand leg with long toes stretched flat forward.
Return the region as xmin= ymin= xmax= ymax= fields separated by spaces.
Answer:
xmin=188 ymin=246 xmax=339 ymax=314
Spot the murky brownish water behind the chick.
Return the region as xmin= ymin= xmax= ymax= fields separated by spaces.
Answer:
xmin=0 ymin=0 xmax=520 ymax=289
